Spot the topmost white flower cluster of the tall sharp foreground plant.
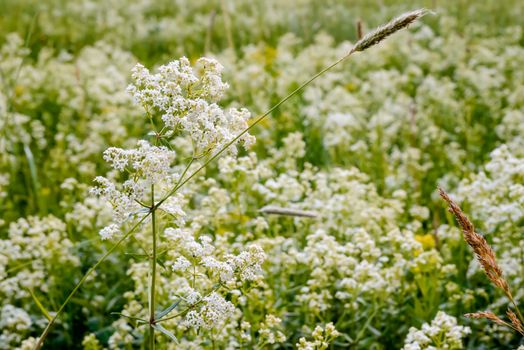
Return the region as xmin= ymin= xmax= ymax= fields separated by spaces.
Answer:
xmin=128 ymin=57 xmax=254 ymax=155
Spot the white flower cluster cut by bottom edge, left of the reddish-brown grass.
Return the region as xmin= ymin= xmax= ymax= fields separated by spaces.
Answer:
xmin=402 ymin=311 xmax=471 ymax=350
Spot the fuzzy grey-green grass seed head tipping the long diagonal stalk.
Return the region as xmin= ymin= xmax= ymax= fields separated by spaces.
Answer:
xmin=351 ymin=9 xmax=430 ymax=52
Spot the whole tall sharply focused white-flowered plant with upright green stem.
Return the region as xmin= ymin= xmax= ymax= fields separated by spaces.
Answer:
xmin=87 ymin=58 xmax=265 ymax=348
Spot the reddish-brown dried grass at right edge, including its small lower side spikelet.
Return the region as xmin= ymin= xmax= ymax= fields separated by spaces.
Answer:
xmin=439 ymin=188 xmax=524 ymax=336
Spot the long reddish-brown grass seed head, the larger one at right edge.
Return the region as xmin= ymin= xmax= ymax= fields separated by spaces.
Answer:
xmin=438 ymin=188 xmax=513 ymax=299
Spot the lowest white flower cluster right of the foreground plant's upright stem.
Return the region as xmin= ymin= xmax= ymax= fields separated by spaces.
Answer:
xmin=165 ymin=228 xmax=265 ymax=330
